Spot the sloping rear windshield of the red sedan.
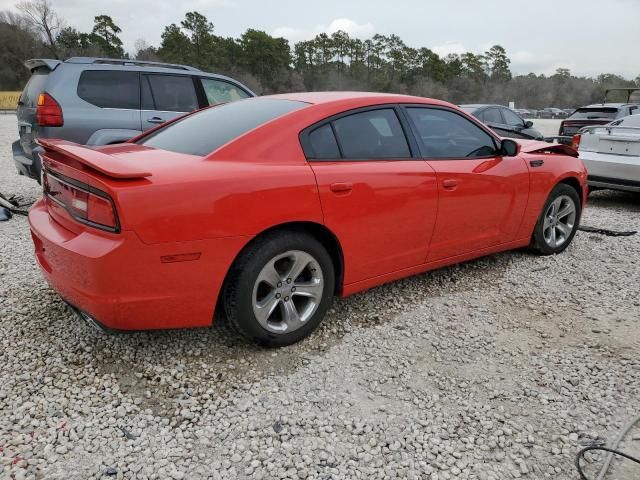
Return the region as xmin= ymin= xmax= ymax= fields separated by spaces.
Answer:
xmin=138 ymin=98 xmax=308 ymax=156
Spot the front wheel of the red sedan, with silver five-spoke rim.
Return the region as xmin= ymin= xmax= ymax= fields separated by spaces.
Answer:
xmin=531 ymin=184 xmax=580 ymax=255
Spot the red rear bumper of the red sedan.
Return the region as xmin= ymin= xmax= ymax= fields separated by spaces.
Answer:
xmin=29 ymin=200 xmax=246 ymax=330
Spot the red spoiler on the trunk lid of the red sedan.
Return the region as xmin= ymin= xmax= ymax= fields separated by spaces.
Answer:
xmin=37 ymin=138 xmax=151 ymax=179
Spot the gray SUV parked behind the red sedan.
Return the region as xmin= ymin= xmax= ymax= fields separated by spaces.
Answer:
xmin=12 ymin=57 xmax=255 ymax=180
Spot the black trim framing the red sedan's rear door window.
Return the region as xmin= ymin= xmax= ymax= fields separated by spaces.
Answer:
xmin=298 ymin=103 xmax=422 ymax=162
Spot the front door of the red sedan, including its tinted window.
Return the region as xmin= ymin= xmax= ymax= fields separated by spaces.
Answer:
xmin=406 ymin=106 xmax=529 ymax=262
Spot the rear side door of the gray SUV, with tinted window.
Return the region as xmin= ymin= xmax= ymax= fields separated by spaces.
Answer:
xmin=141 ymin=73 xmax=204 ymax=130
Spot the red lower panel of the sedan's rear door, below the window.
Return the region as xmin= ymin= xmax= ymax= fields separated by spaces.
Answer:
xmin=311 ymin=159 xmax=438 ymax=284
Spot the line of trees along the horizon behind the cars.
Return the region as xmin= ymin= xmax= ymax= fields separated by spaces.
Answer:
xmin=0 ymin=0 xmax=640 ymax=108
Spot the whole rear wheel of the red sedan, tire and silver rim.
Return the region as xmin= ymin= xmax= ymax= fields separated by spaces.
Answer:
xmin=224 ymin=231 xmax=335 ymax=346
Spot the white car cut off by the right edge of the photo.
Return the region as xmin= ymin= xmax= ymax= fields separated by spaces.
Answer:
xmin=573 ymin=115 xmax=640 ymax=192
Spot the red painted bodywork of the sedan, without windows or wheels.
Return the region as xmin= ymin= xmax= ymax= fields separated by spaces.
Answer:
xmin=29 ymin=93 xmax=586 ymax=329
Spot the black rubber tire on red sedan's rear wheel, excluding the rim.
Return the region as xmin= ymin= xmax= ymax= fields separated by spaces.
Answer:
xmin=223 ymin=230 xmax=335 ymax=347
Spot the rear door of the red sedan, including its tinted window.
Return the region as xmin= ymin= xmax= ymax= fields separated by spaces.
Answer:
xmin=302 ymin=106 xmax=438 ymax=284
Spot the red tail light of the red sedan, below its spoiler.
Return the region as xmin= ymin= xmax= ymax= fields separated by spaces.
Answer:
xmin=42 ymin=170 xmax=120 ymax=233
